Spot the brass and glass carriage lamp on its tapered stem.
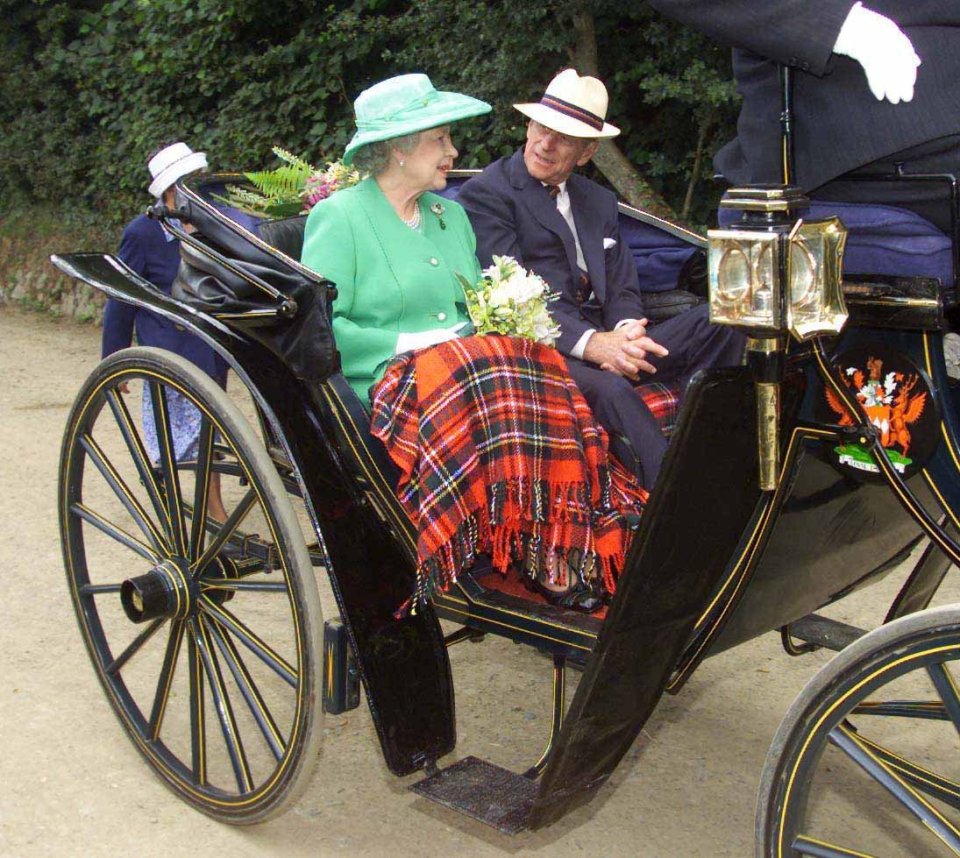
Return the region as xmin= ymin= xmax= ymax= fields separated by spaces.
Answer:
xmin=707 ymin=185 xmax=847 ymax=490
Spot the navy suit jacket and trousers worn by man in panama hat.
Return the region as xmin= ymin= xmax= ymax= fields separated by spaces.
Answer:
xmin=457 ymin=150 xmax=743 ymax=488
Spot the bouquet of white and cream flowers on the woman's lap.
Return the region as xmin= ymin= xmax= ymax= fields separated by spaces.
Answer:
xmin=457 ymin=256 xmax=560 ymax=346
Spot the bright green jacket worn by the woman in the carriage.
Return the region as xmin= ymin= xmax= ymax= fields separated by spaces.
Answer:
xmin=301 ymin=178 xmax=480 ymax=403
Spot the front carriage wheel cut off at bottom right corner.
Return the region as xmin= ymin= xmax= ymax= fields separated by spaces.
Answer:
xmin=756 ymin=605 xmax=960 ymax=858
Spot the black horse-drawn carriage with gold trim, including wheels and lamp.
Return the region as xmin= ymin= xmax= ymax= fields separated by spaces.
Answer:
xmin=54 ymin=147 xmax=960 ymax=855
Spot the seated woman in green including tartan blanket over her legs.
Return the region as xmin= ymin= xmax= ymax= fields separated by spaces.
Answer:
xmin=301 ymin=74 xmax=644 ymax=612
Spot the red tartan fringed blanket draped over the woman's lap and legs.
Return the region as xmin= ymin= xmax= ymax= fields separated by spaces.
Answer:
xmin=371 ymin=336 xmax=647 ymax=604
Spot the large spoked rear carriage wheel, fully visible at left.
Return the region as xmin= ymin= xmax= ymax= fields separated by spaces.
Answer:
xmin=59 ymin=348 xmax=322 ymax=823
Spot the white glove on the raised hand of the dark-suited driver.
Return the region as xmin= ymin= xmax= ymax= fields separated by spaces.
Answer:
xmin=833 ymin=3 xmax=920 ymax=104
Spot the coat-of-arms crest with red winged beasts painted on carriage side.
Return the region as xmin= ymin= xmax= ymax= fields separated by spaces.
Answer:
xmin=824 ymin=349 xmax=939 ymax=476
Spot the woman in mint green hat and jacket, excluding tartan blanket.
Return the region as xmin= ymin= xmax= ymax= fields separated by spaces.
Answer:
xmin=302 ymin=74 xmax=490 ymax=403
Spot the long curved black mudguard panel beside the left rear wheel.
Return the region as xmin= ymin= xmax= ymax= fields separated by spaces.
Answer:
xmin=54 ymin=253 xmax=456 ymax=775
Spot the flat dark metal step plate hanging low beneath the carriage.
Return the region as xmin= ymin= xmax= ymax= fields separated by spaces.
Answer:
xmin=410 ymin=757 xmax=537 ymax=834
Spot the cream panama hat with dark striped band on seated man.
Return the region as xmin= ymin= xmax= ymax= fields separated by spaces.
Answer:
xmin=514 ymin=69 xmax=620 ymax=138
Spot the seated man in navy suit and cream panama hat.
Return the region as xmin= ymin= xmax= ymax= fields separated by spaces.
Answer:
xmin=458 ymin=69 xmax=743 ymax=488
